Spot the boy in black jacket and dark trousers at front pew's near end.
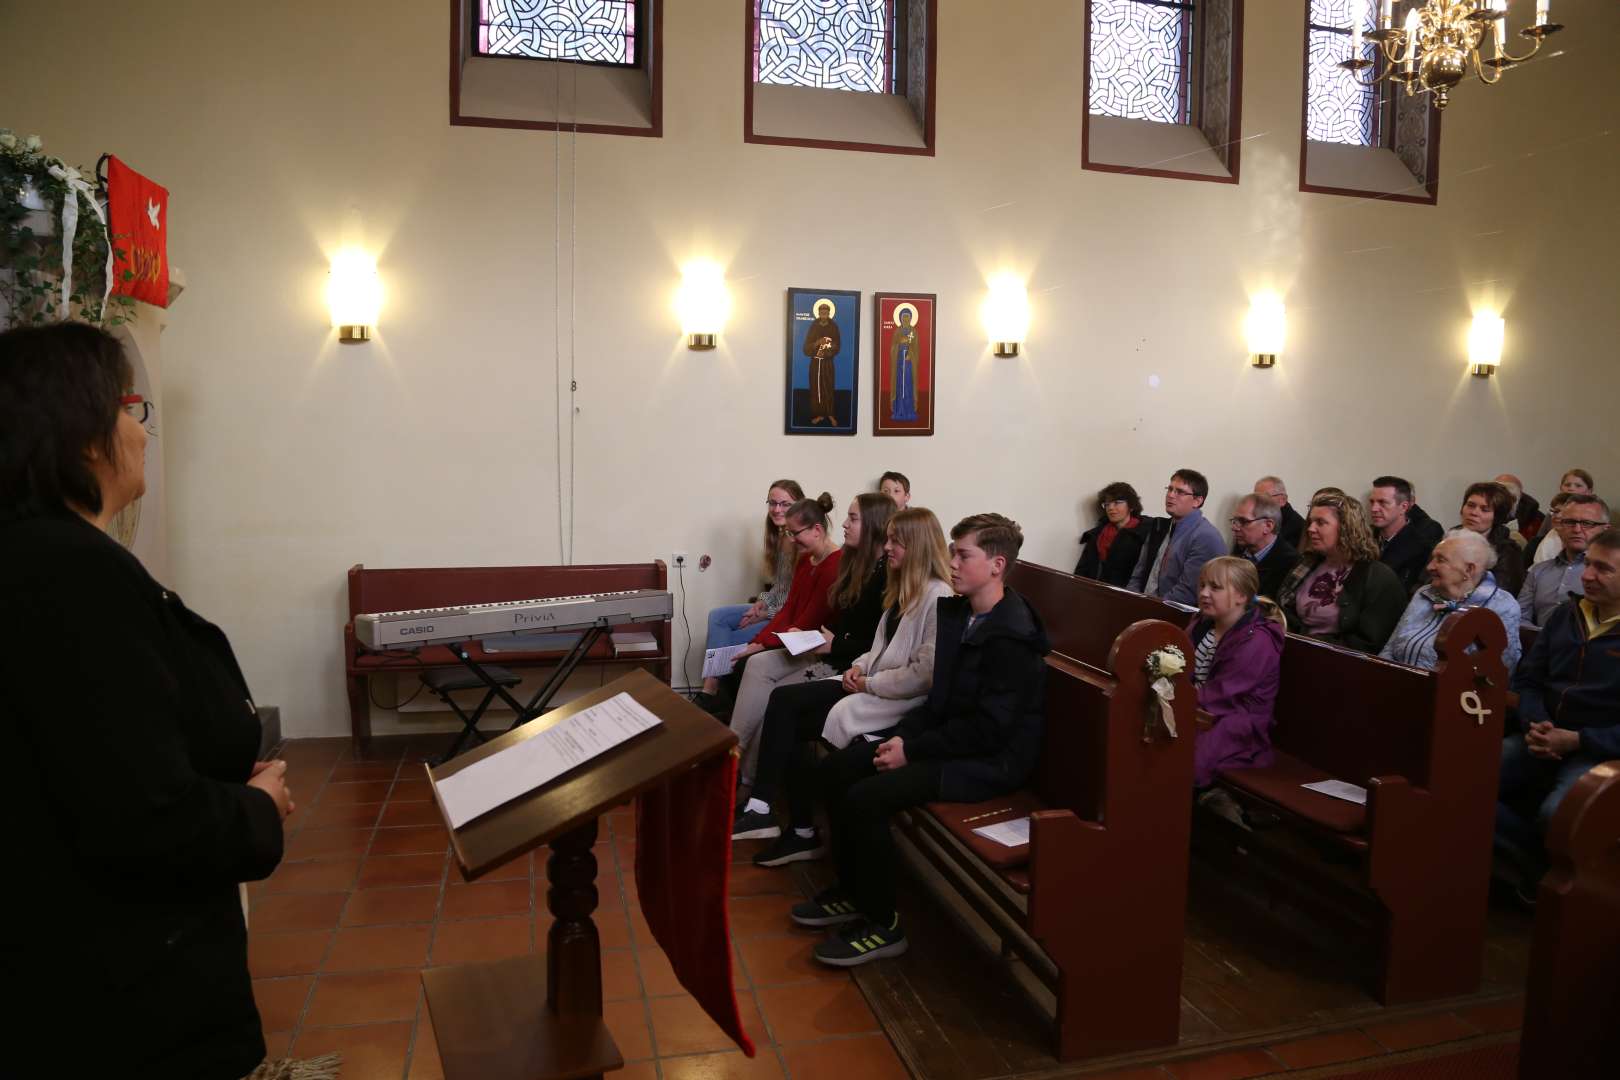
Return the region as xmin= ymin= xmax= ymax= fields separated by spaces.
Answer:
xmin=792 ymin=513 xmax=1050 ymax=967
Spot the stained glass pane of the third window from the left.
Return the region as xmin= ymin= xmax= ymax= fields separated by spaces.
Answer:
xmin=1087 ymin=0 xmax=1194 ymax=123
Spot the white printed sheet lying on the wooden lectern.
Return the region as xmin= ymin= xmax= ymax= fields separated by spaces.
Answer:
xmin=439 ymin=693 xmax=663 ymax=829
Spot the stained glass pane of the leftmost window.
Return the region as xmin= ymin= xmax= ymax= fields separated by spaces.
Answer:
xmin=476 ymin=0 xmax=638 ymax=65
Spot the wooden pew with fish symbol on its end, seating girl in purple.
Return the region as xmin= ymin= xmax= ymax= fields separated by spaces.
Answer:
xmin=1009 ymin=562 xmax=1508 ymax=1004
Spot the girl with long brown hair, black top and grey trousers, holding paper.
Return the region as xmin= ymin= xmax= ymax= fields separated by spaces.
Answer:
xmin=727 ymin=491 xmax=894 ymax=784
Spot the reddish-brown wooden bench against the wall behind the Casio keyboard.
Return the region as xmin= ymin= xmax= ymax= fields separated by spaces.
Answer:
xmin=343 ymin=560 xmax=671 ymax=745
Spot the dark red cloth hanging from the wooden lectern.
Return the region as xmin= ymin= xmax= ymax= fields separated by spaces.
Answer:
xmin=635 ymin=753 xmax=753 ymax=1057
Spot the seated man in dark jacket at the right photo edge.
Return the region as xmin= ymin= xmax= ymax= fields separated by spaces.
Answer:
xmin=1497 ymin=528 xmax=1620 ymax=887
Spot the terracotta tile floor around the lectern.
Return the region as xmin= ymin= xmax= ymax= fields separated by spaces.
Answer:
xmin=248 ymin=737 xmax=906 ymax=1080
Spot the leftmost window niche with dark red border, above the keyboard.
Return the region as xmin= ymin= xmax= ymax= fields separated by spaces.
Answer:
xmin=450 ymin=0 xmax=664 ymax=138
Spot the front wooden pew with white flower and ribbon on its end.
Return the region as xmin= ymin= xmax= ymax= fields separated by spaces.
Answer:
xmin=899 ymin=615 xmax=1194 ymax=1061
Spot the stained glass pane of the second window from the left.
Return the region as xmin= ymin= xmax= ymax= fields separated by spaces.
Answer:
xmin=753 ymin=0 xmax=896 ymax=94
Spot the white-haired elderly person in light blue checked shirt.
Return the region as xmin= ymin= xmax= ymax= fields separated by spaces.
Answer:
xmin=1379 ymin=529 xmax=1520 ymax=672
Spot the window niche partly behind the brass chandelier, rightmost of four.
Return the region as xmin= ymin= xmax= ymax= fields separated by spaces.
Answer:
xmin=1299 ymin=0 xmax=1440 ymax=206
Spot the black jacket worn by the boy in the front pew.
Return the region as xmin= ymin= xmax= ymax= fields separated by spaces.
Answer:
xmin=894 ymin=588 xmax=1051 ymax=803
